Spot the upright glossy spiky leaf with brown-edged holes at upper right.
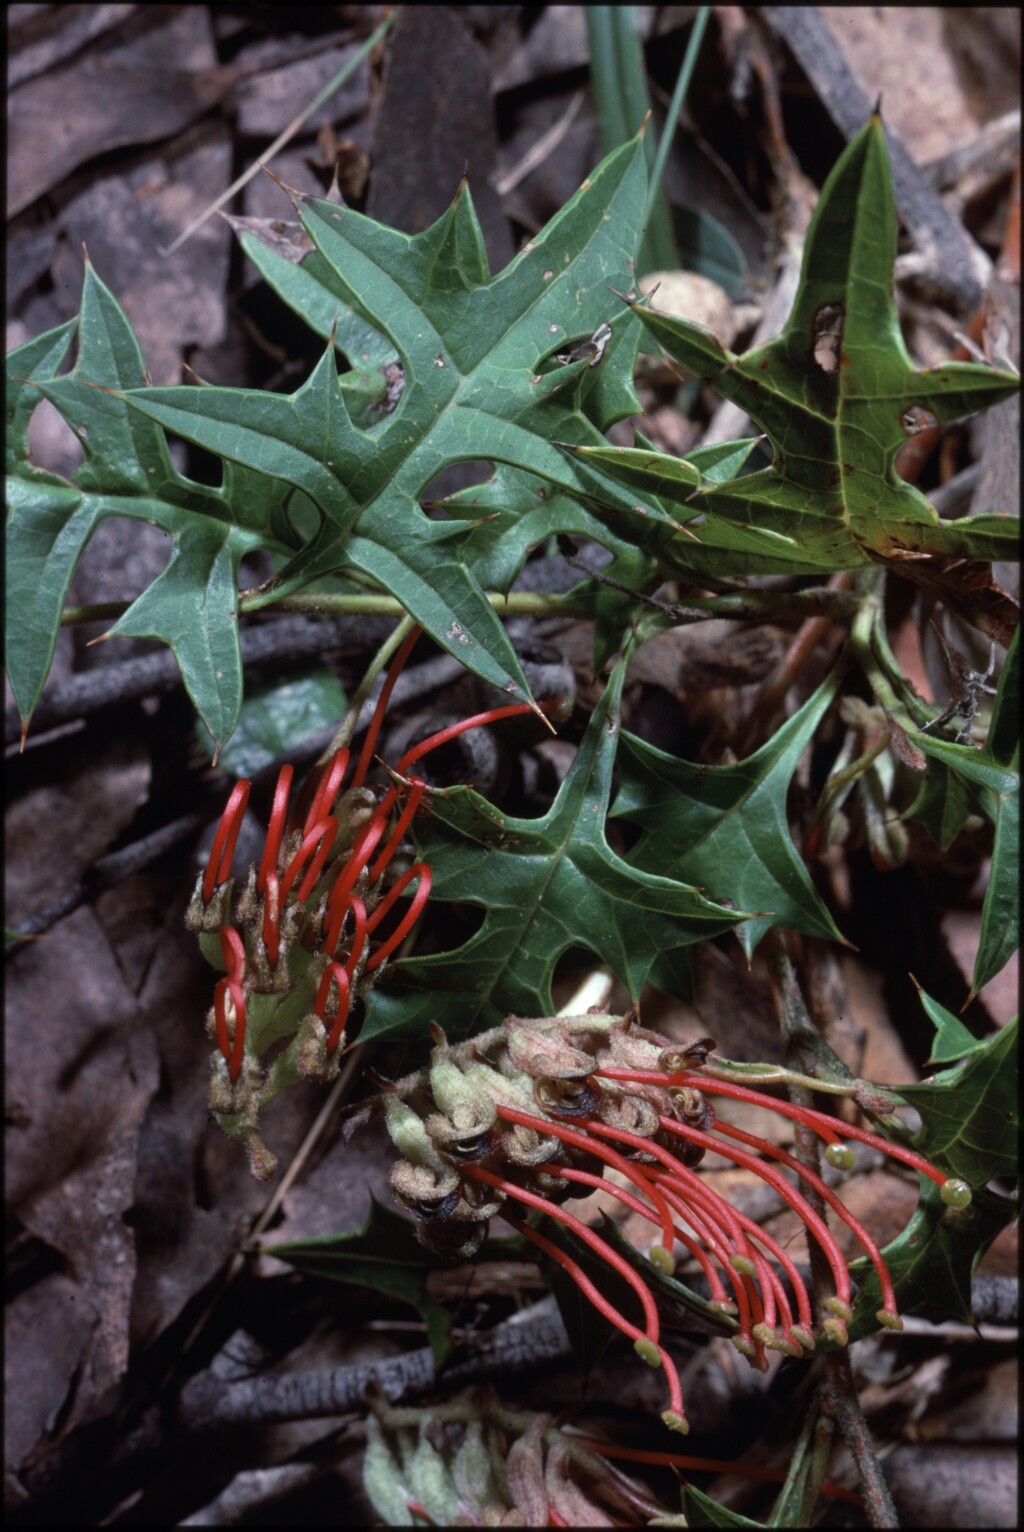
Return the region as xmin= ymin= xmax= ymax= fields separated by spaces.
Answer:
xmin=575 ymin=116 xmax=1019 ymax=584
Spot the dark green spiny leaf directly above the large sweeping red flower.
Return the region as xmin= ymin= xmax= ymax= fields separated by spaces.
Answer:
xmin=360 ymin=660 xmax=745 ymax=1039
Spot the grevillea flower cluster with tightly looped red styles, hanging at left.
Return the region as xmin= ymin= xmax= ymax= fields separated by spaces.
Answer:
xmin=185 ymin=628 xmax=564 ymax=1180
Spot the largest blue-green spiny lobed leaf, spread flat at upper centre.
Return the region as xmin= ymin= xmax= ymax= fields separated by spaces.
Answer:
xmin=110 ymin=141 xmax=656 ymax=707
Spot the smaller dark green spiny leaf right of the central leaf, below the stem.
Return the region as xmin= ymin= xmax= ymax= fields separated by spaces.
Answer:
xmin=612 ymin=671 xmax=843 ymax=954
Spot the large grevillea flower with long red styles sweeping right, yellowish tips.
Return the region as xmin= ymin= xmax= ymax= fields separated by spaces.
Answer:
xmin=385 ymin=1014 xmax=970 ymax=1432
